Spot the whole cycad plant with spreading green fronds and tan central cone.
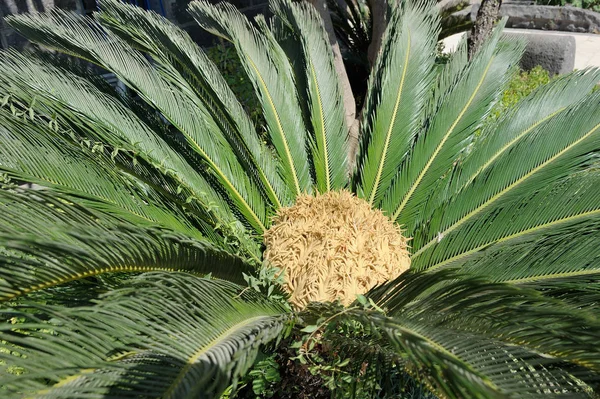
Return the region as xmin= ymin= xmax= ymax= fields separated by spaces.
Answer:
xmin=0 ymin=0 xmax=600 ymax=398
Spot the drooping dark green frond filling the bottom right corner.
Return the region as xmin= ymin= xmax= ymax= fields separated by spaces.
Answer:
xmin=356 ymin=269 xmax=600 ymax=398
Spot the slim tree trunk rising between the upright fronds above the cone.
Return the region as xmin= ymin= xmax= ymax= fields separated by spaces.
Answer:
xmin=308 ymin=0 xmax=358 ymax=172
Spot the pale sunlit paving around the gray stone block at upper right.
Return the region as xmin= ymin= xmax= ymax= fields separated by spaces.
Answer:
xmin=443 ymin=29 xmax=600 ymax=69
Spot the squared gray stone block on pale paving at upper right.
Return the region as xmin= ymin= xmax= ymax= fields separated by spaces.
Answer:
xmin=505 ymin=32 xmax=575 ymax=75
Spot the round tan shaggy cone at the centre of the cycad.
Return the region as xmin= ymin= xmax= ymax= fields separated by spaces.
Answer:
xmin=264 ymin=191 xmax=410 ymax=309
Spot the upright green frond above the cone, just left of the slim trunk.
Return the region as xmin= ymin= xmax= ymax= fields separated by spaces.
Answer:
xmin=271 ymin=1 xmax=348 ymax=193
